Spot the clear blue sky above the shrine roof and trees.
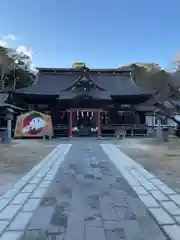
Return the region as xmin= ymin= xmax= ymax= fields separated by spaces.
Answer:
xmin=0 ymin=0 xmax=180 ymax=67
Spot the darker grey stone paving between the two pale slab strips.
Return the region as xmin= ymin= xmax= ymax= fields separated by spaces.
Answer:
xmin=20 ymin=141 xmax=166 ymax=240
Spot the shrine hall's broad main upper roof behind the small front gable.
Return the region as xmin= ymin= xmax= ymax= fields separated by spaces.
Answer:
xmin=9 ymin=69 xmax=152 ymax=96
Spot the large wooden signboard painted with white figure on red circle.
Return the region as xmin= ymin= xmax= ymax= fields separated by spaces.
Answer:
xmin=14 ymin=111 xmax=53 ymax=138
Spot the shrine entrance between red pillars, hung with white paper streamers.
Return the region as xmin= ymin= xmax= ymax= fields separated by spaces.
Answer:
xmin=69 ymin=109 xmax=101 ymax=137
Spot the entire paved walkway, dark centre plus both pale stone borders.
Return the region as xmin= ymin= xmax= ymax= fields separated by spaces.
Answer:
xmin=0 ymin=141 xmax=180 ymax=240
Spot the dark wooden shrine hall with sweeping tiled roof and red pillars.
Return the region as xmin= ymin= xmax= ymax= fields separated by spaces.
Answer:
xmin=6 ymin=63 xmax=152 ymax=137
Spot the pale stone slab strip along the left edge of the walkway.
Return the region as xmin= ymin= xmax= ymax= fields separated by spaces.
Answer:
xmin=0 ymin=144 xmax=71 ymax=240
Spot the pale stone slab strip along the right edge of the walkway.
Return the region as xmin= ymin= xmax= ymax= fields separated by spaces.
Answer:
xmin=101 ymin=144 xmax=180 ymax=240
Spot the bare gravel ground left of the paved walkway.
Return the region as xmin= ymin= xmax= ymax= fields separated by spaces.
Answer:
xmin=0 ymin=140 xmax=57 ymax=195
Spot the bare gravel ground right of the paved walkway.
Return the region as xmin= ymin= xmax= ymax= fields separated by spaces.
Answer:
xmin=116 ymin=138 xmax=180 ymax=192
